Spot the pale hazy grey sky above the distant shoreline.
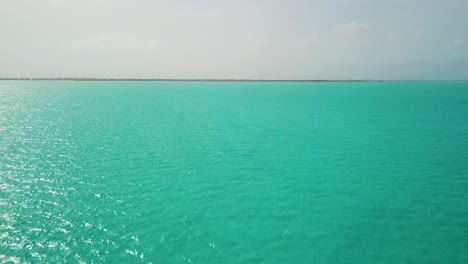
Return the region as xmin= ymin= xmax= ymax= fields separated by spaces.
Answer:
xmin=0 ymin=0 xmax=468 ymax=79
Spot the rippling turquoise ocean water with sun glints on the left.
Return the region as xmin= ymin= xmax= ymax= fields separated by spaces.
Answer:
xmin=0 ymin=81 xmax=468 ymax=264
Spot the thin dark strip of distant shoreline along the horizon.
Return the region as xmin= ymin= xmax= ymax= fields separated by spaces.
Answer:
xmin=0 ymin=78 xmax=468 ymax=82
